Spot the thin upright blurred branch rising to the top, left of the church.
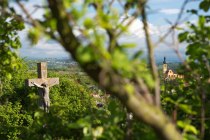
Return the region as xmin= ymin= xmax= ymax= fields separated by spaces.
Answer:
xmin=138 ymin=0 xmax=160 ymax=107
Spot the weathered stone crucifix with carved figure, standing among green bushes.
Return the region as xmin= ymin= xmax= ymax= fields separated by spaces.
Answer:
xmin=26 ymin=62 xmax=59 ymax=112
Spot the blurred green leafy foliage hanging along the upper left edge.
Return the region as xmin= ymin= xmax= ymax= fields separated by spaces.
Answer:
xmin=0 ymin=1 xmax=24 ymax=80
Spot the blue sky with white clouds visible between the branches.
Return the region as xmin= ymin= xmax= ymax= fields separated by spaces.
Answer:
xmin=12 ymin=0 xmax=202 ymax=61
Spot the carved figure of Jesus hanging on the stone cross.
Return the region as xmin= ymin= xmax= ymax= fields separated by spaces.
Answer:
xmin=31 ymin=82 xmax=50 ymax=112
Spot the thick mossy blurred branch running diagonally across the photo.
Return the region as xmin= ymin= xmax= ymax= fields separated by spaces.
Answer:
xmin=48 ymin=0 xmax=182 ymax=140
